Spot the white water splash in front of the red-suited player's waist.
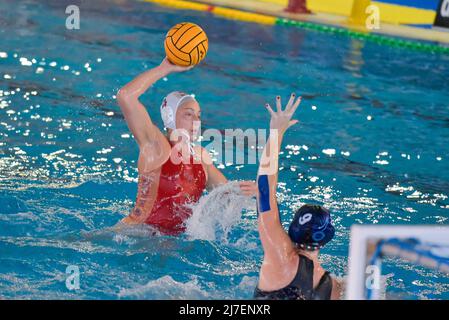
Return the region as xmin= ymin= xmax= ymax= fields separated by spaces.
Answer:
xmin=186 ymin=181 xmax=256 ymax=242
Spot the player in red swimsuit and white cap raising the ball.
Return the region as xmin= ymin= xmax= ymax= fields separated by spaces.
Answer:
xmin=117 ymin=59 xmax=257 ymax=235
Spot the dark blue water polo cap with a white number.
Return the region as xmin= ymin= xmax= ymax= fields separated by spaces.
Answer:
xmin=288 ymin=204 xmax=335 ymax=250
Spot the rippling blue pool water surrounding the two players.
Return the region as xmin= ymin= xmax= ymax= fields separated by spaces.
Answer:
xmin=0 ymin=0 xmax=449 ymax=299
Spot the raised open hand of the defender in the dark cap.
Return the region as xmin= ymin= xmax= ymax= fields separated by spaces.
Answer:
xmin=265 ymin=93 xmax=301 ymax=134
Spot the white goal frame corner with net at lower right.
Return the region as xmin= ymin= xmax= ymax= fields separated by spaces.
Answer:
xmin=346 ymin=225 xmax=449 ymax=300
